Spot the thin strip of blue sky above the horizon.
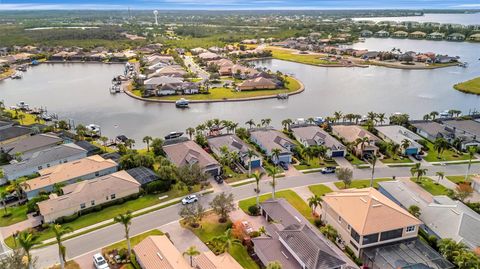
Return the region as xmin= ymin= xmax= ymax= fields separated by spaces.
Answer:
xmin=0 ymin=0 xmax=480 ymax=10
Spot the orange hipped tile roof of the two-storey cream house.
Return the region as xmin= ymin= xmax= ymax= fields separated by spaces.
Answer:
xmin=323 ymin=188 xmax=422 ymax=235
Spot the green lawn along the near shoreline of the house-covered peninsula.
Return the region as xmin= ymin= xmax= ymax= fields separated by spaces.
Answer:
xmin=140 ymin=77 xmax=300 ymax=100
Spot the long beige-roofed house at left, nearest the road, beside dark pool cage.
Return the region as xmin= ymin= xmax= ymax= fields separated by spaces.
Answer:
xmin=38 ymin=171 xmax=140 ymax=223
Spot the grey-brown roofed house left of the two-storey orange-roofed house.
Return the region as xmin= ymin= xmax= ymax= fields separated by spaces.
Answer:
xmin=252 ymin=199 xmax=348 ymax=269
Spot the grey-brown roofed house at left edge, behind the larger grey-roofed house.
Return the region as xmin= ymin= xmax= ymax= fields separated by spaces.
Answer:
xmin=0 ymin=133 xmax=63 ymax=157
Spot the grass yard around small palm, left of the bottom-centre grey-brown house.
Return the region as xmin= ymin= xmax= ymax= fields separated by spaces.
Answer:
xmin=181 ymin=213 xmax=259 ymax=269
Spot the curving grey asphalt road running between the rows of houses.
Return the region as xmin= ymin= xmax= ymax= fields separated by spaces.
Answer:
xmin=33 ymin=161 xmax=480 ymax=268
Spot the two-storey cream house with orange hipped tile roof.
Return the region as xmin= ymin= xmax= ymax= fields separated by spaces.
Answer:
xmin=322 ymin=188 xmax=422 ymax=254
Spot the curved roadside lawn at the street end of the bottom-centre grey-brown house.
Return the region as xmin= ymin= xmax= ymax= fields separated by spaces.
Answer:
xmin=238 ymin=187 xmax=313 ymax=221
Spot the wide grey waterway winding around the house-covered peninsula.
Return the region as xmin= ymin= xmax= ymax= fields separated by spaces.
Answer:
xmin=0 ymin=39 xmax=480 ymax=143
